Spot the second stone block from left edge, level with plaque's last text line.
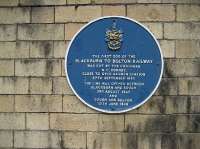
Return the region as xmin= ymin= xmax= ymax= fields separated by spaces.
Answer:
xmin=15 ymin=95 xmax=62 ymax=112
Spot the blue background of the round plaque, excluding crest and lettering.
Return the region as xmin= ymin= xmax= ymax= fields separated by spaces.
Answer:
xmin=66 ymin=17 xmax=162 ymax=112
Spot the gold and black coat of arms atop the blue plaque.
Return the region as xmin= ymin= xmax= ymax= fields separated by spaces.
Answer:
xmin=106 ymin=20 xmax=123 ymax=51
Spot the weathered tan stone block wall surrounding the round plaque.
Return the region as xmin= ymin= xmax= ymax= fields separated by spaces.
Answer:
xmin=0 ymin=0 xmax=200 ymax=149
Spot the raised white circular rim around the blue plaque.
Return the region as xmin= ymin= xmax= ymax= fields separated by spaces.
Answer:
xmin=65 ymin=15 xmax=164 ymax=114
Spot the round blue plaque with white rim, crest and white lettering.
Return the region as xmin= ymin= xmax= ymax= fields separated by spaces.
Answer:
xmin=65 ymin=16 xmax=163 ymax=113
